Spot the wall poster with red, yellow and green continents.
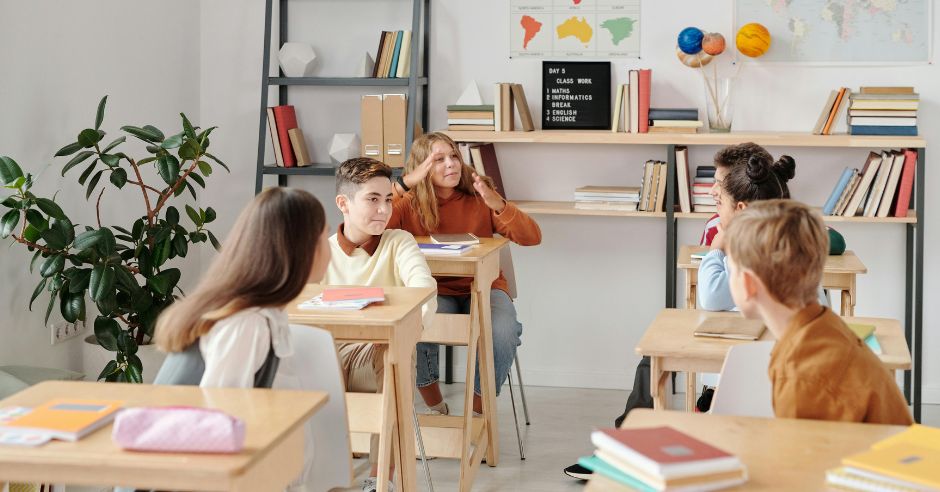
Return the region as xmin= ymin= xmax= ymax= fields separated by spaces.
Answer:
xmin=509 ymin=0 xmax=640 ymax=60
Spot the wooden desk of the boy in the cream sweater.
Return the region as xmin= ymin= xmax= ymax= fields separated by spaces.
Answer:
xmin=287 ymin=284 xmax=437 ymax=492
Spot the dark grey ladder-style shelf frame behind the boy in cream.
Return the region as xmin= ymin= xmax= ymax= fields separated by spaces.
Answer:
xmin=255 ymin=0 xmax=431 ymax=191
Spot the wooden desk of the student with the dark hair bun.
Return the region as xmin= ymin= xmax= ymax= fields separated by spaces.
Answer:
xmin=676 ymin=246 xmax=868 ymax=316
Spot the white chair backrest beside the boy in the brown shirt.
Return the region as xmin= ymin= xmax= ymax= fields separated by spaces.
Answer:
xmin=711 ymin=341 xmax=774 ymax=417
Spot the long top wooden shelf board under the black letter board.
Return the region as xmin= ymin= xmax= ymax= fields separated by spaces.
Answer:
xmin=444 ymin=130 xmax=927 ymax=149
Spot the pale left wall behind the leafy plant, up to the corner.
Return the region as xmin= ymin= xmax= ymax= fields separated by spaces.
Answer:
xmin=0 ymin=0 xmax=200 ymax=379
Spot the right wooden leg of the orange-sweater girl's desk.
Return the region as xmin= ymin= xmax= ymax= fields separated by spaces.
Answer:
xmin=478 ymin=281 xmax=499 ymax=467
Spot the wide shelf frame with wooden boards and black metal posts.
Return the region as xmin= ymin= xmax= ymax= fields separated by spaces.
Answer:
xmin=444 ymin=130 xmax=927 ymax=422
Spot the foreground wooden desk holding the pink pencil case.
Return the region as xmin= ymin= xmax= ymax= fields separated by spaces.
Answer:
xmin=0 ymin=381 xmax=328 ymax=491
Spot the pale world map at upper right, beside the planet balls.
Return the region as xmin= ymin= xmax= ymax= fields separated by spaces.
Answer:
xmin=734 ymin=0 xmax=933 ymax=64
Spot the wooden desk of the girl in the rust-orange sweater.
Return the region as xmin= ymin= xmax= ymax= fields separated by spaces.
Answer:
xmin=415 ymin=236 xmax=509 ymax=490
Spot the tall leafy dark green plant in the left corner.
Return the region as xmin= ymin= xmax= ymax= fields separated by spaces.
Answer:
xmin=0 ymin=96 xmax=228 ymax=383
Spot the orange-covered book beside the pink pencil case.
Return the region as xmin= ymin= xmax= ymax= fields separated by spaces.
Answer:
xmin=0 ymin=398 xmax=124 ymax=441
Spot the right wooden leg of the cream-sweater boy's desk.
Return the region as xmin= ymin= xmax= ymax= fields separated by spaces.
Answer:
xmin=386 ymin=310 xmax=421 ymax=490
